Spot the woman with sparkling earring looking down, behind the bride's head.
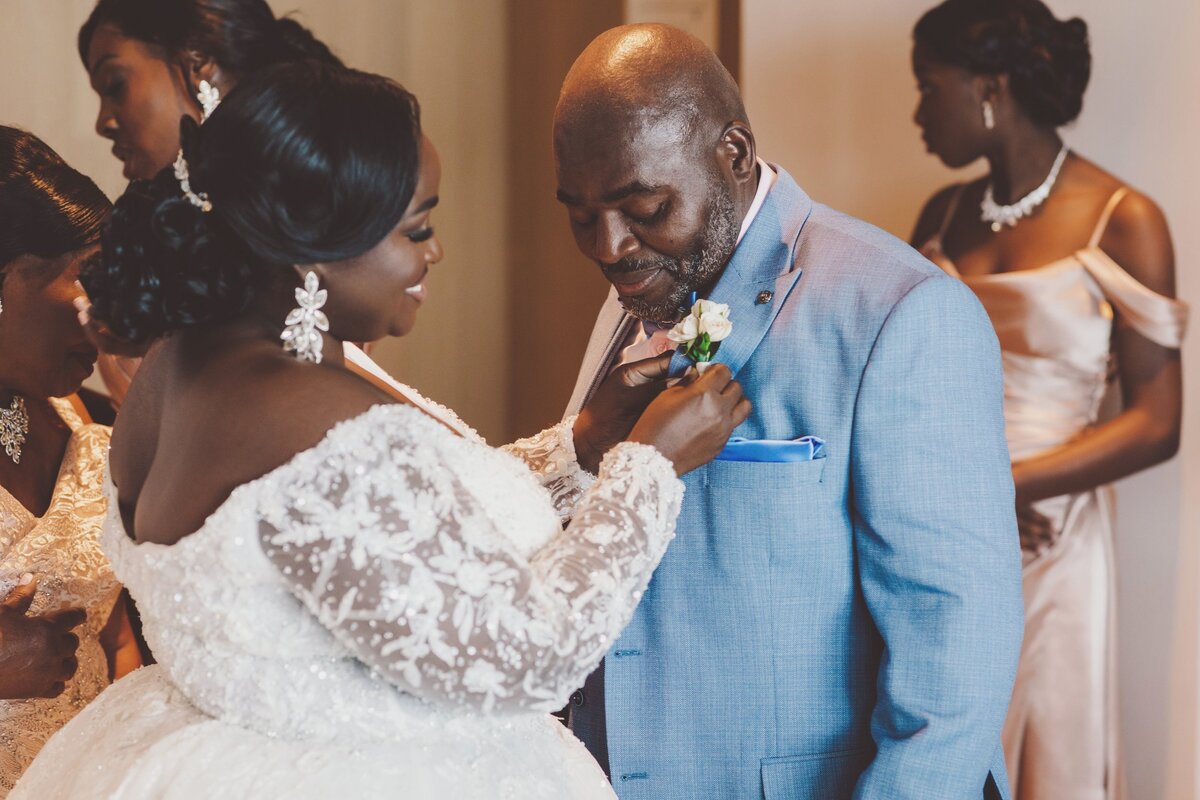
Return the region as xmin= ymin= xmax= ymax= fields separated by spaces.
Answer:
xmin=78 ymin=0 xmax=341 ymax=405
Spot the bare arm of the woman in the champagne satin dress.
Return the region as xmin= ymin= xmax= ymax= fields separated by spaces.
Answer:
xmin=1013 ymin=193 xmax=1183 ymax=506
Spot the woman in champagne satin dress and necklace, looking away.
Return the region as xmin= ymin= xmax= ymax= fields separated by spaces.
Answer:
xmin=912 ymin=0 xmax=1187 ymax=800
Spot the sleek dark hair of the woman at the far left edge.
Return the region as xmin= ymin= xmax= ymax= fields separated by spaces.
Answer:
xmin=0 ymin=126 xmax=112 ymax=289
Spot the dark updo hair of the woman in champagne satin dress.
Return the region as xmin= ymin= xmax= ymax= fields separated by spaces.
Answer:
xmin=913 ymin=0 xmax=1092 ymax=127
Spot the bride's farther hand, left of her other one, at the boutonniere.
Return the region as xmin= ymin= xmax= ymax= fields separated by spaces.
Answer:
xmin=572 ymin=351 xmax=674 ymax=475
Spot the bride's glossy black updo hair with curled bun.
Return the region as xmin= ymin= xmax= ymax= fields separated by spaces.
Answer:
xmin=80 ymin=61 xmax=421 ymax=342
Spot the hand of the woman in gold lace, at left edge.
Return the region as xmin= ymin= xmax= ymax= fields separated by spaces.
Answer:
xmin=0 ymin=575 xmax=86 ymax=700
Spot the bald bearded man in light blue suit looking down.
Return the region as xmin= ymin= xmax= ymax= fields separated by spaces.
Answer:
xmin=554 ymin=25 xmax=1022 ymax=800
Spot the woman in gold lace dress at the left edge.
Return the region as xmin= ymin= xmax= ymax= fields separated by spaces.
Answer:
xmin=0 ymin=127 xmax=139 ymax=795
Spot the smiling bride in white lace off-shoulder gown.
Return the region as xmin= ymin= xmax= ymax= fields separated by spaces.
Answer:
xmin=12 ymin=65 xmax=749 ymax=800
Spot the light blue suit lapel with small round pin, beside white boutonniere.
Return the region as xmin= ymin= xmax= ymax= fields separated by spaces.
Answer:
xmin=671 ymin=164 xmax=812 ymax=377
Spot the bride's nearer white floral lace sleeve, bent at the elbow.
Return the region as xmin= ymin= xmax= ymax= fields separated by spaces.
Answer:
xmin=259 ymin=407 xmax=683 ymax=711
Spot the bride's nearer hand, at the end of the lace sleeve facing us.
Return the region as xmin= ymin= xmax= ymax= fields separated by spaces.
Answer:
xmin=629 ymin=363 xmax=751 ymax=475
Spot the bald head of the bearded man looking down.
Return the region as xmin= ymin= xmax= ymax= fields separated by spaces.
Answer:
xmin=554 ymin=25 xmax=758 ymax=321
